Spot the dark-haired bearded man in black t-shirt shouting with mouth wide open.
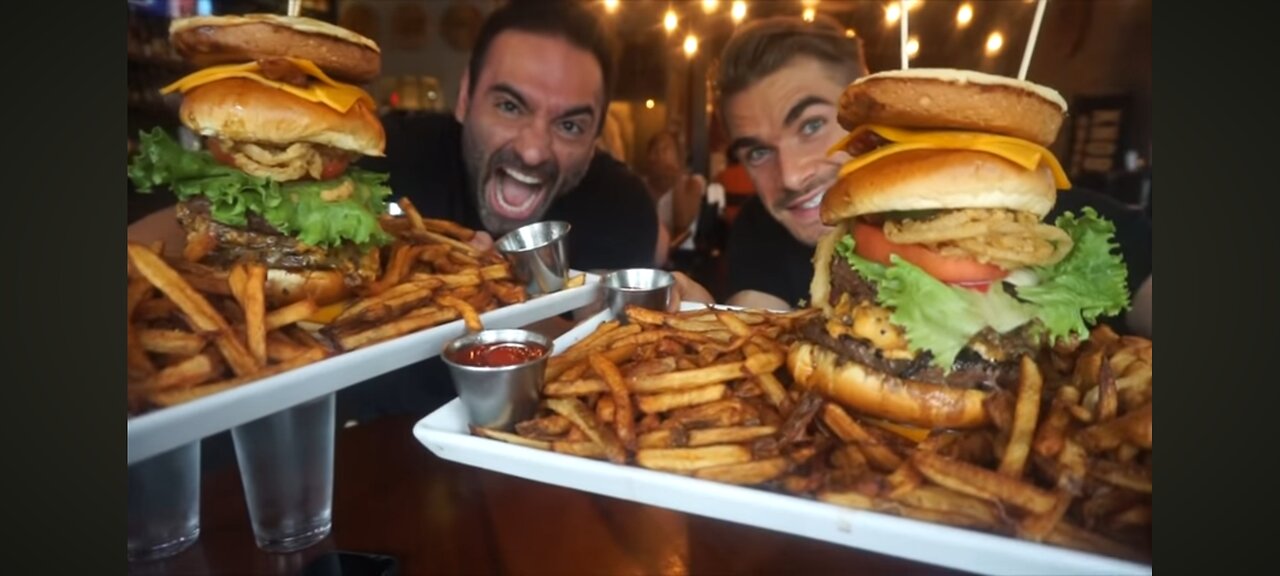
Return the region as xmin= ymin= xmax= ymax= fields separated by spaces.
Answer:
xmin=367 ymin=1 xmax=658 ymax=270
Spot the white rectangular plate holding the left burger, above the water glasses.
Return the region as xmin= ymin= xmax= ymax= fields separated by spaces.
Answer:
xmin=128 ymin=270 xmax=600 ymax=463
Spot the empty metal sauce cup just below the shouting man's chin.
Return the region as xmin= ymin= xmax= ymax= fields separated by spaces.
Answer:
xmin=494 ymin=220 xmax=570 ymax=297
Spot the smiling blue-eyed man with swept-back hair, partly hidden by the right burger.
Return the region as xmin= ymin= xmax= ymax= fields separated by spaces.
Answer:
xmin=717 ymin=17 xmax=867 ymax=308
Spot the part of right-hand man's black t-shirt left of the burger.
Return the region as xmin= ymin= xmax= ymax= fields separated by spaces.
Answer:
xmin=726 ymin=196 xmax=814 ymax=306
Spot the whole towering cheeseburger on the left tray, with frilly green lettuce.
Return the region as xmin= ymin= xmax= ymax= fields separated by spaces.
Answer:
xmin=129 ymin=14 xmax=390 ymax=305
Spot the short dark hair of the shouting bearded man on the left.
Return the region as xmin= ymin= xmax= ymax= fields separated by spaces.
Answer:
xmin=467 ymin=0 xmax=617 ymax=108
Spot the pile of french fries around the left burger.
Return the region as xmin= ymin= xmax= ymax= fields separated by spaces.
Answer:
xmin=127 ymin=200 xmax=527 ymax=416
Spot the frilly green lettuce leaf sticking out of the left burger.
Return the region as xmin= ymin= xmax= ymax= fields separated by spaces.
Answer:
xmin=128 ymin=128 xmax=392 ymax=250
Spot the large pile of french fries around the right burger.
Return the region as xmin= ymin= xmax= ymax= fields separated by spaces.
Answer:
xmin=471 ymin=307 xmax=1152 ymax=562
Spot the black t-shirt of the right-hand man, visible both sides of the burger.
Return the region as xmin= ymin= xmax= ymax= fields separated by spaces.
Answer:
xmin=727 ymin=188 xmax=1152 ymax=332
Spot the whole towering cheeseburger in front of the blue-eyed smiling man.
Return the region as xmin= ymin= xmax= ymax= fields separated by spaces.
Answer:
xmin=787 ymin=69 xmax=1129 ymax=429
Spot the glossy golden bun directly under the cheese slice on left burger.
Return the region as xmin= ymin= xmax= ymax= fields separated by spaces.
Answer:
xmin=178 ymin=78 xmax=387 ymax=156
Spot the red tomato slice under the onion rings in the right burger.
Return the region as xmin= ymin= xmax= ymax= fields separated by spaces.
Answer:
xmin=854 ymin=223 xmax=1009 ymax=284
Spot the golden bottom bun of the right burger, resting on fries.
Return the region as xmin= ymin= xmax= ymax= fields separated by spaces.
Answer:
xmin=787 ymin=342 xmax=988 ymax=429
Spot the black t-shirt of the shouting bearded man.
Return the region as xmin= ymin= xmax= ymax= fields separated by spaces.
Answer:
xmin=361 ymin=114 xmax=658 ymax=270
